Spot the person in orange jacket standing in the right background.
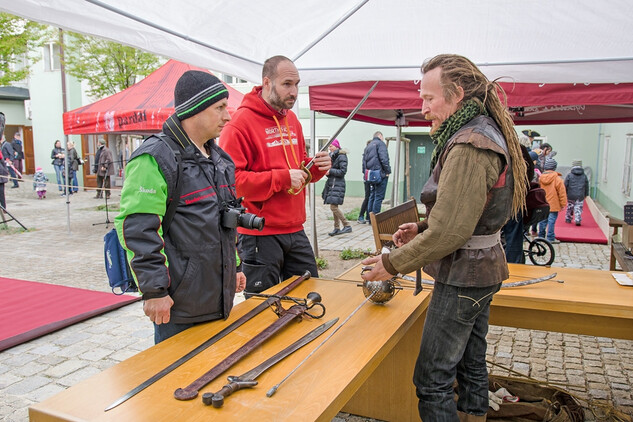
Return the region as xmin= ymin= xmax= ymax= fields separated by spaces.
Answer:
xmin=538 ymin=158 xmax=567 ymax=243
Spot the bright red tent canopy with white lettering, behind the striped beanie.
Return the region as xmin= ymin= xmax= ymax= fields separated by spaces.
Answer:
xmin=64 ymin=60 xmax=244 ymax=135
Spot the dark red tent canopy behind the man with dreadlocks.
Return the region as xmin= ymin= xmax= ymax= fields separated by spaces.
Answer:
xmin=309 ymin=81 xmax=633 ymax=126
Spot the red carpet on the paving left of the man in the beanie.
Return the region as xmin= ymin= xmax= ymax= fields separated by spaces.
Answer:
xmin=0 ymin=277 xmax=141 ymax=351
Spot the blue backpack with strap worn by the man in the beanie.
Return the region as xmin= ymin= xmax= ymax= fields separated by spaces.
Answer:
xmin=103 ymin=133 xmax=182 ymax=295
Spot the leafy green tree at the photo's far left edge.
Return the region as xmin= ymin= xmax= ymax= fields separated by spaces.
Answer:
xmin=0 ymin=13 xmax=46 ymax=86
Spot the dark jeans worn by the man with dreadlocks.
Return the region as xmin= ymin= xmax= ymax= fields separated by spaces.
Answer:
xmin=413 ymin=282 xmax=501 ymax=422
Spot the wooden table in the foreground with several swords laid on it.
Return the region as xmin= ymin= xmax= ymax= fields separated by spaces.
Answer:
xmin=29 ymin=279 xmax=429 ymax=422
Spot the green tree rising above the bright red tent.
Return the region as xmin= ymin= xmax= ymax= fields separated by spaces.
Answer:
xmin=64 ymin=33 xmax=161 ymax=98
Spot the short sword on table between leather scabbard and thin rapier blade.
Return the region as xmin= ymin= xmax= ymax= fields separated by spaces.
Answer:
xmin=202 ymin=317 xmax=338 ymax=408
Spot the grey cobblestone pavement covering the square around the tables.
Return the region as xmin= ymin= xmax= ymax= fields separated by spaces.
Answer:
xmin=0 ymin=182 xmax=633 ymax=422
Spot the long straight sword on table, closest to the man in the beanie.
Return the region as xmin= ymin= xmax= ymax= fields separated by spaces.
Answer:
xmin=104 ymin=271 xmax=312 ymax=412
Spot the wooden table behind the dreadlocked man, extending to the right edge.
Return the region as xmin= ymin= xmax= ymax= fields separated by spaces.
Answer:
xmin=339 ymin=264 xmax=633 ymax=340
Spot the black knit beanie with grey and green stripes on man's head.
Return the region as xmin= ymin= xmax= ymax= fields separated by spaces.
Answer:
xmin=174 ymin=70 xmax=229 ymax=120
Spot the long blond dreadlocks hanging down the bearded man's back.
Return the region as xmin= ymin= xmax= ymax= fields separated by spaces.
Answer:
xmin=421 ymin=54 xmax=529 ymax=218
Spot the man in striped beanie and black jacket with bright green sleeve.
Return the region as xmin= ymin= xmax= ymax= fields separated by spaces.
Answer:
xmin=115 ymin=70 xmax=246 ymax=343
